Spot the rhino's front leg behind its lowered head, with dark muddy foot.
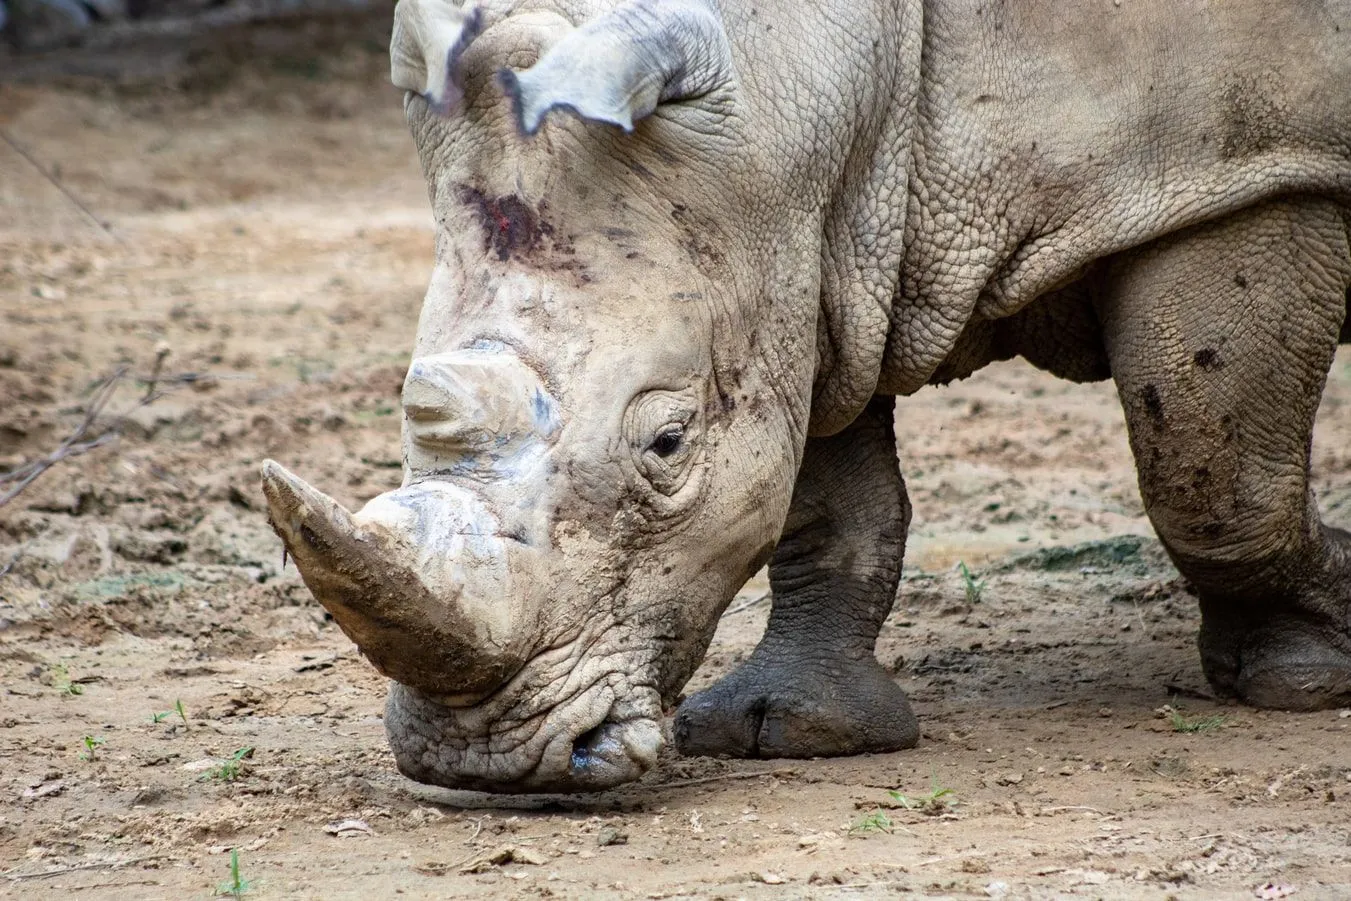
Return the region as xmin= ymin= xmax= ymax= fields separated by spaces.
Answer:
xmin=676 ymin=397 xmax=919 ymax=758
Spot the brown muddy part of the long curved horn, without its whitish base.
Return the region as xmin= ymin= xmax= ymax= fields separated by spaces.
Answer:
xmin=262 ymin=459 xmax=520 ymax=704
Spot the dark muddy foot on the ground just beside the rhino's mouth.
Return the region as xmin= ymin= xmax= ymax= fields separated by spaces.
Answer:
xmin=676 ymin=654 xmax=920 ymax=758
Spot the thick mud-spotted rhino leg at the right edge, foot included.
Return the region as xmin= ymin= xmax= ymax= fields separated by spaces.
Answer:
xmin=1098 ymin=197 xmax=1351 ymax=709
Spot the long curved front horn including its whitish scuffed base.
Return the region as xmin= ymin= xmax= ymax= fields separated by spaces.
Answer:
xmin=262 ymin=461 xmax=521 ymax=704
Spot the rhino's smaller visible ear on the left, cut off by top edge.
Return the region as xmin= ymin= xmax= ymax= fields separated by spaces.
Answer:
xmin=389 ymin=0 xmax=484 ymax=115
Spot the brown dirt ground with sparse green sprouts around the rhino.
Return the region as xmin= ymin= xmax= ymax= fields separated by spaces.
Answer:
xmin=0 ymin=19 xmax=1351 ymax=900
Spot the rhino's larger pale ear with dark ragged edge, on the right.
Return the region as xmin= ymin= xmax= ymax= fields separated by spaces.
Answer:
xmin=497 ymin=0 xmax=734 ymax=135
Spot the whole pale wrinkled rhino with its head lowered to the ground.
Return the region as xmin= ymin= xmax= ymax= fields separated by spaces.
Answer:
xmin=265 ymin=0 xmax=1351 ymax=792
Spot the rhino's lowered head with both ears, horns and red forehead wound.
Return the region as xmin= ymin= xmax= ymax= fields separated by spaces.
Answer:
xmin=263 ymin=0 xmax=885 ymax=792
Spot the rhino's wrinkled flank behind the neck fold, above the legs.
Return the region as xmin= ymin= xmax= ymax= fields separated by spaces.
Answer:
xmin=882 ymin=0 xmax=1351 ymax=393
